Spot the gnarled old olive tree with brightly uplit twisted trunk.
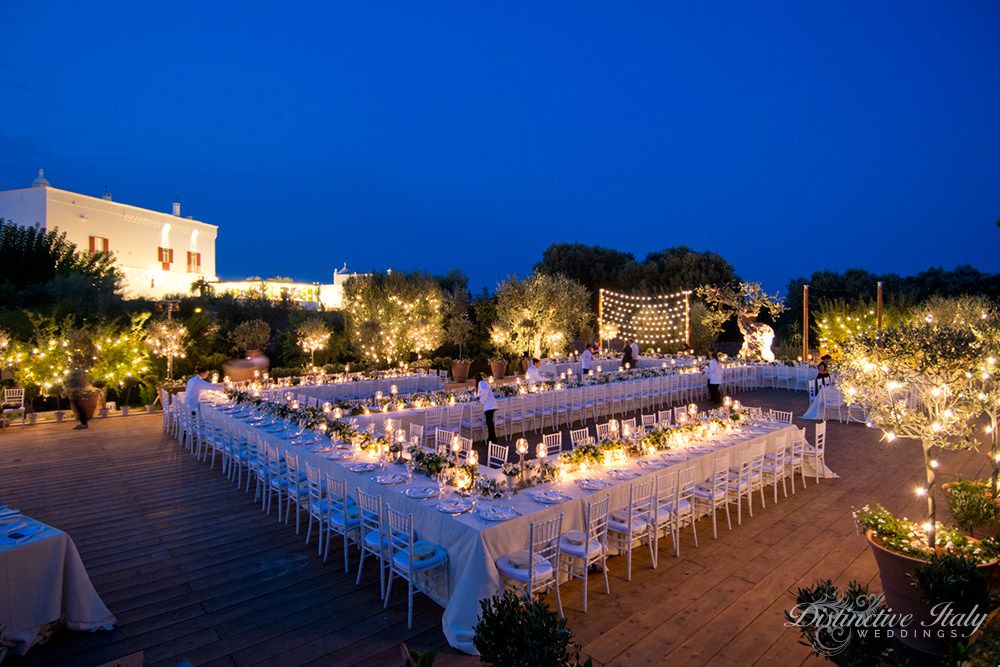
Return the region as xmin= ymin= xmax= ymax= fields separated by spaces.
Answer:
xmin=697 ymin=283 xmax=785 ymax=361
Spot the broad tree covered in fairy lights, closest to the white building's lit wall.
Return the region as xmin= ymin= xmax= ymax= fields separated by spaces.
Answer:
xmin=344 ymin=273 xmax=444 ymax=364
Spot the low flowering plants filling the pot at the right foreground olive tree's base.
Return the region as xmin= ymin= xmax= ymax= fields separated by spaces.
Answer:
xmin=852 ymin=505 xmax=1000 ymax=563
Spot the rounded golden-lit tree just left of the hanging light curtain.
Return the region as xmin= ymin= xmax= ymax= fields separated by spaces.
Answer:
xmin=491 ymin=273 xmax=590 ymax=357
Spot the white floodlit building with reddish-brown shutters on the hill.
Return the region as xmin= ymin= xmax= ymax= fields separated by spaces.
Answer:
xmin=0 ymin=169 xmax=219 ymax=298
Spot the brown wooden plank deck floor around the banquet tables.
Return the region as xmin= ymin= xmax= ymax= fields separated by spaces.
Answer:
xmin=0 ymin=390 xmax=987 ymax=667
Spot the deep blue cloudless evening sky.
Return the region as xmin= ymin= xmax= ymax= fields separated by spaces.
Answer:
xmin=0 ymin=0 xmax=1000 ymax=290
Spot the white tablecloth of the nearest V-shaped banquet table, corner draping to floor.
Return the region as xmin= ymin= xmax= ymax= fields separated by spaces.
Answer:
xmin=202 ymin=404 xmax=835 ymax=654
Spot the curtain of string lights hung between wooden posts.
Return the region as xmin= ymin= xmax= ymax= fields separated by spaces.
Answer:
xmin=597 ymin=289 xmax=691 ymax=347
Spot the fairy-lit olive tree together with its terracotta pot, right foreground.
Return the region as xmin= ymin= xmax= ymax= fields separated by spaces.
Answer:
xmin=840 ymin=318 xmax=997 ymax=652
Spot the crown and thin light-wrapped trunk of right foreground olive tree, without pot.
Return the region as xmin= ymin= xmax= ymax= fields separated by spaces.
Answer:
xmin=839 ymin=318 xmax=982 ymax=549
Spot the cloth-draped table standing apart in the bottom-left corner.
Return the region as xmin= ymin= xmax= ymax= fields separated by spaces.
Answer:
xmin=0 ymin=508 xmax=116 ymax=660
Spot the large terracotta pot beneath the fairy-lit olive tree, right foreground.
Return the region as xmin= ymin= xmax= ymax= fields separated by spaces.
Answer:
xmin=865 ymin=530 xmax=1000 ymax=655
